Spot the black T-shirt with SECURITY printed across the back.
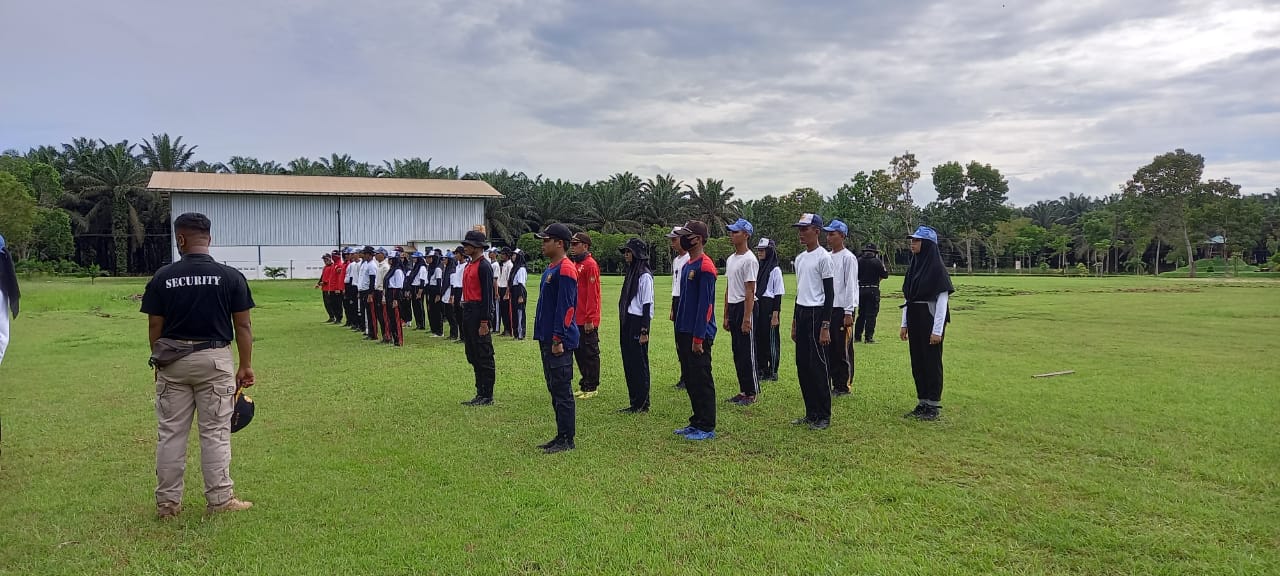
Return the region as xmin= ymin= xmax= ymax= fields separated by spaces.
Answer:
xmin=142 ymin=253 xmax=253 ymax=342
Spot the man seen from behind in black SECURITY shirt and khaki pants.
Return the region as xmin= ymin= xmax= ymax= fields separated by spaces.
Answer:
xmin=142 ymin=212 xmax=253 ymax=518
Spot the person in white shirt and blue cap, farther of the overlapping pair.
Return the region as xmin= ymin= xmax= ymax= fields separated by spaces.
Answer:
xmin=823 ymin=220 xmax=858 ymax=397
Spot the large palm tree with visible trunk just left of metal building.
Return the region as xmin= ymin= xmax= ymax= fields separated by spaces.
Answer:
xmin=72 ymin=141 xmax=151 ymax=274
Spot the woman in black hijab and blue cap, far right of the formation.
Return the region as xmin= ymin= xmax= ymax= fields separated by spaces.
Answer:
xmin=900 ymin=227 xmax=955 ymax=420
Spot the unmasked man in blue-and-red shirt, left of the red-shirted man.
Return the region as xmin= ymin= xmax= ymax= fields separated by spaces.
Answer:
xmin=534 ymin=224 xmax=579 ymax=454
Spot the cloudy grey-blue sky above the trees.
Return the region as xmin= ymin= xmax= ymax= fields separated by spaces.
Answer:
xmin=0 ymin=0 xmax=1280 ymax=204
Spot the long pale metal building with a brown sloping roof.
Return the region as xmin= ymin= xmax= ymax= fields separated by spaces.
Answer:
xmin=147 ymin=172 xmax=500 ymax=279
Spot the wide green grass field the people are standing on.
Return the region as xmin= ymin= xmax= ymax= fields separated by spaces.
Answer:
xmin=0 ymin=272 xmax=1280 ymax=576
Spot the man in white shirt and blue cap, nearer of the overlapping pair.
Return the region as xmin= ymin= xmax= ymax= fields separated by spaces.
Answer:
xmin=791 ymin=214 xmax=836 ymax=430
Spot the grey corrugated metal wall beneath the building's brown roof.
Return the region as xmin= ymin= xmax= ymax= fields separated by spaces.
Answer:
xmin=172 ymin=193 xmax=484 ymax=250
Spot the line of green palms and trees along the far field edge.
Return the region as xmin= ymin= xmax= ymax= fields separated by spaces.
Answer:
xmin=0 ymin=134 xmax=1280 ymax=275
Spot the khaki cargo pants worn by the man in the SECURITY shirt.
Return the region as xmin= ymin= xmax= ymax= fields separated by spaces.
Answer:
xmin=156 ymin=347 xmax=236 ymax=506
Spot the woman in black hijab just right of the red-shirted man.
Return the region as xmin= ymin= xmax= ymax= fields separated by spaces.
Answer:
xmin=618 ymin=238 xmax=653 ymax=413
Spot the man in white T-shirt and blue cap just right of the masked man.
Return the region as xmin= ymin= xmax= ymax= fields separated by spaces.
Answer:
xmin=724 ymin=218 xmax=752 ymax=406
